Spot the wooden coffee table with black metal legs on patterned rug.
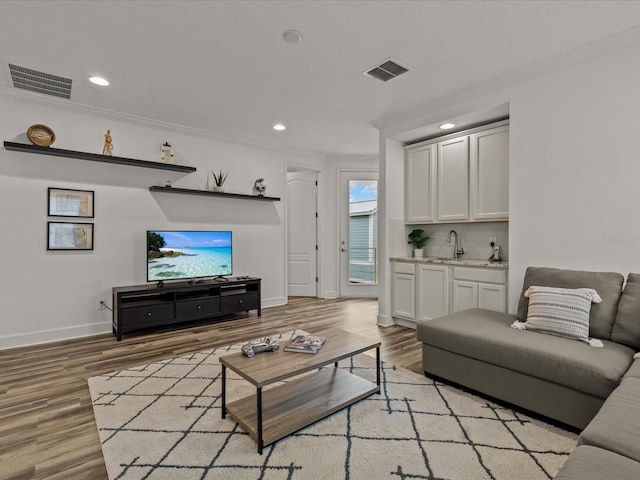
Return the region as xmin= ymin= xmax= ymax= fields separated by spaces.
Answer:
xmin=220 ymin=329 xmax=380 ymax=454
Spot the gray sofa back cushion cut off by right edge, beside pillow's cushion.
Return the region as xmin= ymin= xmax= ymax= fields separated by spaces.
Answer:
xmin=611 ymin=273 xmax=640 ymax=350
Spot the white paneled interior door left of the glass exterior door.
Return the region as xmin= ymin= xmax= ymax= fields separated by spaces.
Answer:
xmin=287 ymin=172 xmax=318 ymax=297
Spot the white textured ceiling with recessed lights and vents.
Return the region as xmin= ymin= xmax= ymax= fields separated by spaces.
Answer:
xmin=0 ymin=0 xmax=640 ymax=155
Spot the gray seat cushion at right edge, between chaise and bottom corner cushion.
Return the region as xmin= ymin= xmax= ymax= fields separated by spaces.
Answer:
xmin=578 ymin=376 xmax=640 ymax=464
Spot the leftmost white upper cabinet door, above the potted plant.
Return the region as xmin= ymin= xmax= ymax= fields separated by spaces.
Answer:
xmin=405 ymin=145 xmax=436 ymax=223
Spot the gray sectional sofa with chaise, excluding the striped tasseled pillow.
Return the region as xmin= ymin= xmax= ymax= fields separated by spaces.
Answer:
xmin=417 ymin=267 xmax=640 ymax=480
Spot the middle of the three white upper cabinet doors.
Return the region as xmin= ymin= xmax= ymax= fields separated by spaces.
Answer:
xmin=437 ymin=136 xmax=469 ymax=222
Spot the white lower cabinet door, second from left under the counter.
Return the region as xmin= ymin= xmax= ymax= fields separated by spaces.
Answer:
xmin=416 ymin=265 xmax=449 ymax=321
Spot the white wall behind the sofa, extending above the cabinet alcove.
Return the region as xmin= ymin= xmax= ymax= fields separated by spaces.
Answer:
xmin=381 ymin=39 xmax=640 ymax=312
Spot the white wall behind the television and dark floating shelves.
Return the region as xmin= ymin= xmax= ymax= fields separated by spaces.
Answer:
xmin=0 ymin=92 xmax=322 ymax=348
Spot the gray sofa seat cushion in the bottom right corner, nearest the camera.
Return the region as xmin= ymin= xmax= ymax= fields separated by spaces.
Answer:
xmin=553 ymin=445 xmax=640 ymax=480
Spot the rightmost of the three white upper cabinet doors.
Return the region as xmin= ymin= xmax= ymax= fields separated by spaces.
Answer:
xmin=470 ymin=126 xmax=509 ymax=220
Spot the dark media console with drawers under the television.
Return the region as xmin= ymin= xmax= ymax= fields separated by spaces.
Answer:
xmin=112 ymin=277 xmax=262 ymax=341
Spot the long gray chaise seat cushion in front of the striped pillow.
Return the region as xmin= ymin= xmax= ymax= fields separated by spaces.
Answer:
xmin=417 ymin=308 xmax=634 ymax=398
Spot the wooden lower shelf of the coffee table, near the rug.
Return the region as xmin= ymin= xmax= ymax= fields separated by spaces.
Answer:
xmin=226 ymin=368 xmax=380 ymax=451
